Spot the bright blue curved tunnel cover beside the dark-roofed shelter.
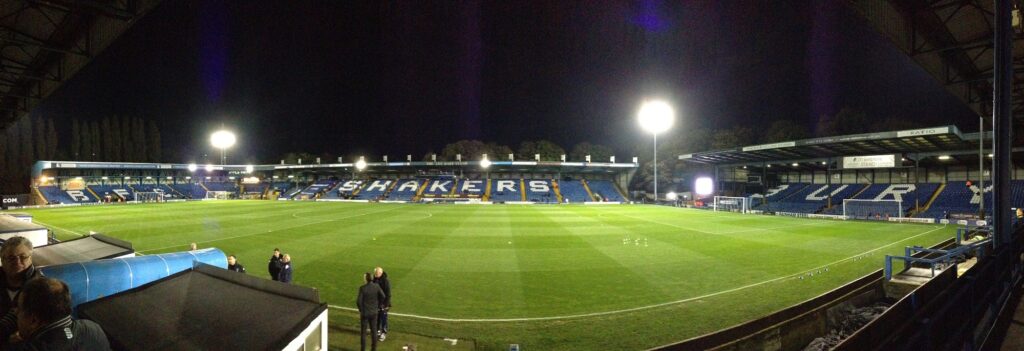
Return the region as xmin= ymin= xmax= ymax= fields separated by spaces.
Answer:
xmin=39 ymin=249 xmax=227 ymax=307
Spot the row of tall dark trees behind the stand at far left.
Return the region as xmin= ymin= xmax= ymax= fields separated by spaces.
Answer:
xmin=0 ymin=116 xmax=163 ymax=193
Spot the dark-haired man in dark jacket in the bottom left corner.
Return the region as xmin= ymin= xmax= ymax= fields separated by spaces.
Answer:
xmin=3 ymin=277 xmax=111 ymax=351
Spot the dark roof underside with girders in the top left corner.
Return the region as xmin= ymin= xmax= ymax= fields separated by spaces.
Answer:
xmin=0 ymin=0 xmax=160 ymax=129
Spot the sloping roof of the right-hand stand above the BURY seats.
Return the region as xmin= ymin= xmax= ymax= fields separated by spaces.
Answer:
xmin=679 ymin=126 xmax=992 ymax=166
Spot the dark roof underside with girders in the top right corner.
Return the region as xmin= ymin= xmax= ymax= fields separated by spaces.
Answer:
xmin=848 ymin=0 xmax=1024 ymax=118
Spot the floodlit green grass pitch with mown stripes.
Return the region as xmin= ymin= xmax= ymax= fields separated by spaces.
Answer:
xmin=8 ymin=201 xmax=954 ymax=350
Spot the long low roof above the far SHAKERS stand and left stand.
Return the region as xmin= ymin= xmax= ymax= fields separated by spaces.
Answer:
xmin=32 ymin=161 xmax=639 ymax=178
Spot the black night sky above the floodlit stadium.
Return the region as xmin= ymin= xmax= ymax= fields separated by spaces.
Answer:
xmin=33 ymin=0 xmax=976 ymax=163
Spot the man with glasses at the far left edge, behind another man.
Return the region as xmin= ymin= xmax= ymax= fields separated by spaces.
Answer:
xmin=0 ymin=236 xmax=40 ymax=341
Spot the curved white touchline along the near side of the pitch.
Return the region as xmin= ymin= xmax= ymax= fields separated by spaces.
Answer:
xmin=328 ymin=226 xmax=944 ymax=322
